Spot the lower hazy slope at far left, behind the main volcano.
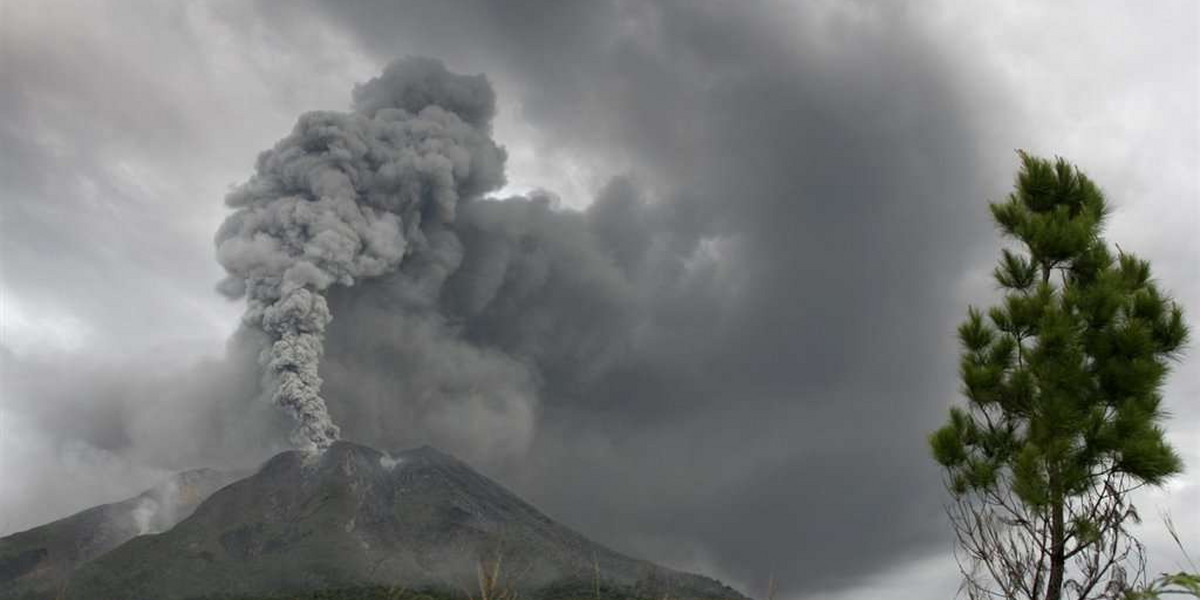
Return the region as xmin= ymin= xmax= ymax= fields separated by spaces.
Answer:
xmin=0 ymin=469 xmax=244 ymax=598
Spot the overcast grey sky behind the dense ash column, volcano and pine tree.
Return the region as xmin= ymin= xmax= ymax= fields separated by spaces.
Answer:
xmin=0 ymin=0 xmax=1200 ymax=599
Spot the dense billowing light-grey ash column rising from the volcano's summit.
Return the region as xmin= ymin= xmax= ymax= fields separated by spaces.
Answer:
xmin=216 ymin=58 xmax=505 ymax=450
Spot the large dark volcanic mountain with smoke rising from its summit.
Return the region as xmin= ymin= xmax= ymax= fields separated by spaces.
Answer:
xmin=0 ymin=442 xmax=744 ymax=600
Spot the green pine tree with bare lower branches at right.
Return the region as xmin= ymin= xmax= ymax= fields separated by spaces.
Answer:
xmin=929 ymin=152 xmax=1188 ymax=600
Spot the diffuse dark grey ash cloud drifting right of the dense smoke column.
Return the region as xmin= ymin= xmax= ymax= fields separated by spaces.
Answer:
xmin=241 ymin=1 xmax=1016 ymax=593
